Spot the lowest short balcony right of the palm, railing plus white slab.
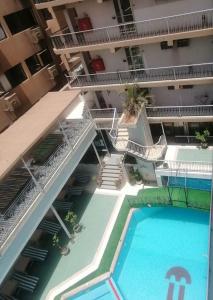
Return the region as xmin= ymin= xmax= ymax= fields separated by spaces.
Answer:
xmin=146 ymin=105 xmax=213 ymax=123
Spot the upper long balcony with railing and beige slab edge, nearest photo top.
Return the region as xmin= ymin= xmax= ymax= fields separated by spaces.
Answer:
xmin=52 ymin=9 xmax=213 ymax=54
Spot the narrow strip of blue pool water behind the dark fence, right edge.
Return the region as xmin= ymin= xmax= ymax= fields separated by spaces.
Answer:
xmin=168 ymin=176 xmax=211 ymax=192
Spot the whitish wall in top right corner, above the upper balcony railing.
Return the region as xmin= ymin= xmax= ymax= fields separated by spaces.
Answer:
xmin=132 ymin=0 xmax=213 ymax=21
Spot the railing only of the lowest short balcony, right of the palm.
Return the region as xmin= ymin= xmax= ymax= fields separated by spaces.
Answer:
xmin=146 ymin=105 xmax=213 ymax=118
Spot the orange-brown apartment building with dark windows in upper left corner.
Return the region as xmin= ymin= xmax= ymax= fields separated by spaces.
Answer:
xmin=0 ymin=0 xmax=62 ymax=132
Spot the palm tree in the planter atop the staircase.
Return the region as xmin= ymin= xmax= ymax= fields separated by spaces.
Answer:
xmin=124 ymin=85 xmax=152 ymax=117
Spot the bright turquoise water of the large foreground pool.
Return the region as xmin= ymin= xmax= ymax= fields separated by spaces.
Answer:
xmin=70 ymin=207 xmax=209 ymax=300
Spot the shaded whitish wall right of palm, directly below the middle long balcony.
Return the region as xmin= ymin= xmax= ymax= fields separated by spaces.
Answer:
xmin=151 ymin=85 xmax=213 ymax=106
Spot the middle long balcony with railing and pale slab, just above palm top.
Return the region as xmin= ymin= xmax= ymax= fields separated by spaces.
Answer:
xmin=67 ymin=63 xmax=213 ymax=90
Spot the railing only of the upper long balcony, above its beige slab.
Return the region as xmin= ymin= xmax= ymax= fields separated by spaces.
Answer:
xmin=51 ymin=8 xmax=213 ymax=49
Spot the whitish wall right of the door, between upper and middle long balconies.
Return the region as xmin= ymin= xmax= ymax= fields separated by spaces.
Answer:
xmin=141 ymin=37 xmax=213 ymax=68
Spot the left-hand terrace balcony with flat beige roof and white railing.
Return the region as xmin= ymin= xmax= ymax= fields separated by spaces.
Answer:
xmin=0 ymin=92 xmax=95 ymax=253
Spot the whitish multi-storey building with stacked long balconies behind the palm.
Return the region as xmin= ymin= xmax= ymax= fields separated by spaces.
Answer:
xmin=35 ymin=0 xmax=213 ymax=142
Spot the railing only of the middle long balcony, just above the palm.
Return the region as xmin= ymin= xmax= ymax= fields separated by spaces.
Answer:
xmin=67 ymin=63 xmax=213 ymax=87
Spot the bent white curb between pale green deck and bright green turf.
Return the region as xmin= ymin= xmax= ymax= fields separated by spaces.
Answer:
xmin=60 ymin=208 xmax=137 ymax=300
